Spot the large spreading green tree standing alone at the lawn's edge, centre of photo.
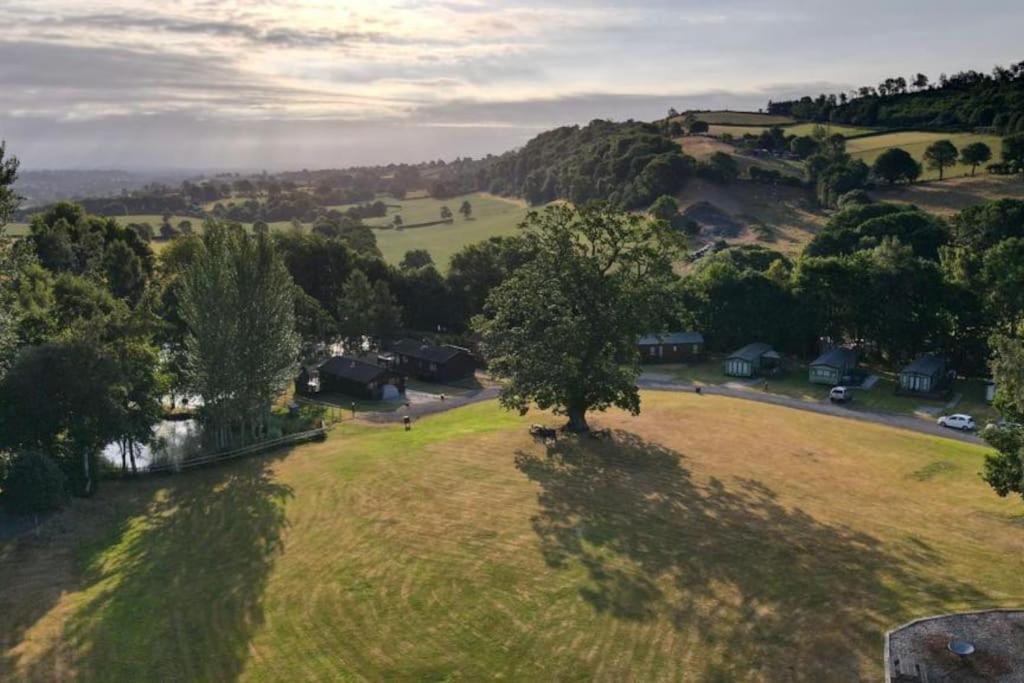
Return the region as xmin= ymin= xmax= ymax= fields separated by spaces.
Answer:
xmin=474 ymin=204 xmax=680 ymax=431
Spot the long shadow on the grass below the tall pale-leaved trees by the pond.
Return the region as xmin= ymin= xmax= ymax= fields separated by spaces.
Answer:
xmin=0 ymin=452 xmax=292 ymax=681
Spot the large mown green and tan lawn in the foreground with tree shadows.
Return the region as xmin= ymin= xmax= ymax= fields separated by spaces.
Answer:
xmin=0 ymin=393 xmax=1024 ymax=681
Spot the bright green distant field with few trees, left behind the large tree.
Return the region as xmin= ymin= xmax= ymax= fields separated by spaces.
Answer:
xmin=366 ymin=193 xmax=527 ymax=271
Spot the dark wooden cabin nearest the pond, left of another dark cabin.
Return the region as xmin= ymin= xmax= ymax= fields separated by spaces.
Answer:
xmin=295 ymin=355 xmax=406 ymax=400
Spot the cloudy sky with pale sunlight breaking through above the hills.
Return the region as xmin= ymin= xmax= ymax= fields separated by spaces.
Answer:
xmin=0 ymin=0 xmax=1024 ymax=170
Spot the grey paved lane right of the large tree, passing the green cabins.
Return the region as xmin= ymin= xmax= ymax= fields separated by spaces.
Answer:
xmin=637 ymin=377 xmax=984 ymax=443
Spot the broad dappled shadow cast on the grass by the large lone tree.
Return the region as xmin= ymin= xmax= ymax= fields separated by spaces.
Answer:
xmin=516 ymin=431 xmax=986 ymax=680
